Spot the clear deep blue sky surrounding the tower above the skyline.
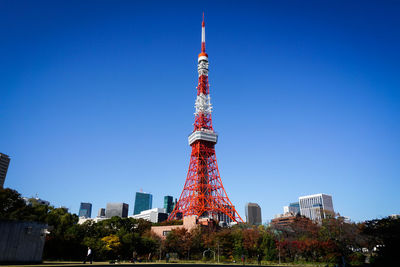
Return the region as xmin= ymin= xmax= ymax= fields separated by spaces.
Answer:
xmin=0 ymin=0 xmax=400 ymax=221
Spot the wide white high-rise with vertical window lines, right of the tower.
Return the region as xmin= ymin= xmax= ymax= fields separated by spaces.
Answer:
xmin=299 ymin=194 xmax=335 ymax=221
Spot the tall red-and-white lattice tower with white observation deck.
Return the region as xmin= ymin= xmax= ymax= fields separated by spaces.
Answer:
xmin=168 ymin=16 xmax=243 ymax=223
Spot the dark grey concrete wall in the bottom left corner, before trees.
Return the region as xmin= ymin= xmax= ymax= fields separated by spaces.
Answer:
xmin=0 ymin=221 xmax=47 ymax=264
